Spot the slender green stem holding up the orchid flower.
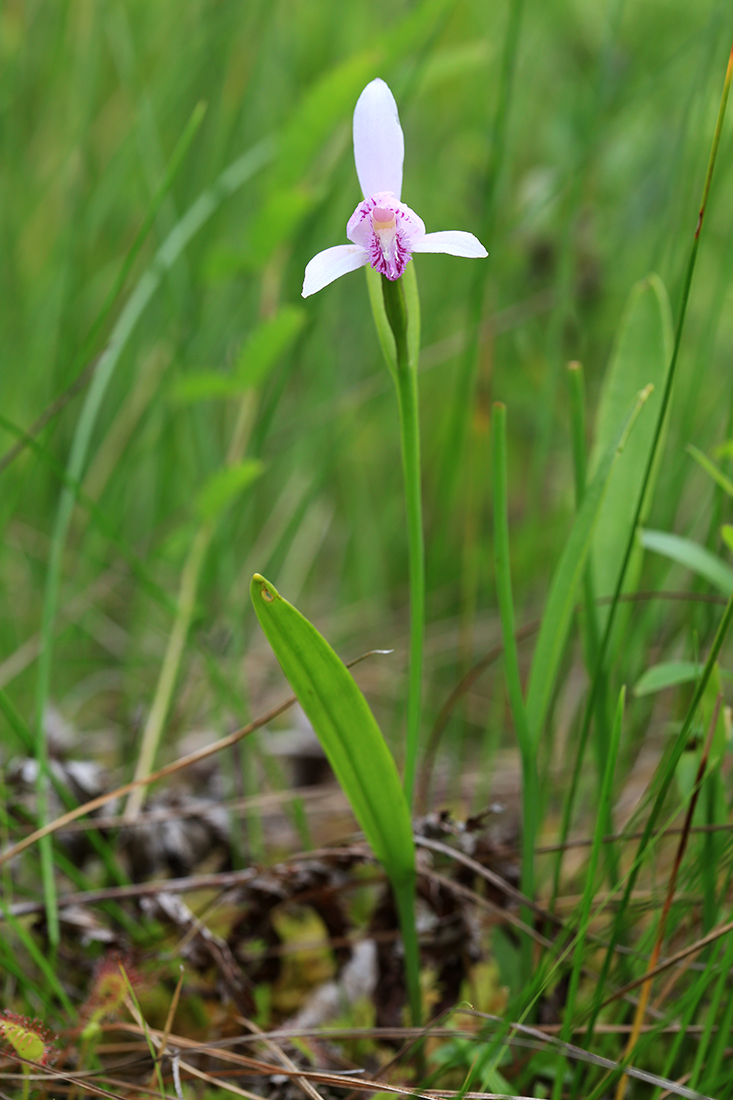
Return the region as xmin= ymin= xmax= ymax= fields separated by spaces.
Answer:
xmin=382 ymin=276 xmax=425 ymax=812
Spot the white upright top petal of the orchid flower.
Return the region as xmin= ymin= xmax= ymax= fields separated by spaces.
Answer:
xmin=353 ymin=79 xmax=405 ymax=199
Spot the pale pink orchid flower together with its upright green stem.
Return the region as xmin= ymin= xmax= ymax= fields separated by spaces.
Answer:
xmin=303 ymin=80 xmax=486 ymax=806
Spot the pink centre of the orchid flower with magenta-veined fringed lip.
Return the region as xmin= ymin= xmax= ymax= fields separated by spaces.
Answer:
xmin=347 ymin=191 xmax=425 ymax=281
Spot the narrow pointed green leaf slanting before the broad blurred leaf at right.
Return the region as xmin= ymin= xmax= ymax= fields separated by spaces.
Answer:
xmin=526 ymin=386 xmax=652 ymax=745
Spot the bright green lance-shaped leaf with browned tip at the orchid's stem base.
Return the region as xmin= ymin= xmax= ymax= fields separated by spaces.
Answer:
xmin=251 ymin=573 xmax=415 ymax=886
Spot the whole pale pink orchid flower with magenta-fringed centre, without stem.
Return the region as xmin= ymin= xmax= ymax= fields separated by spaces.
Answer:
xmin=303 ymin=79 xmax=488 ymax=298
